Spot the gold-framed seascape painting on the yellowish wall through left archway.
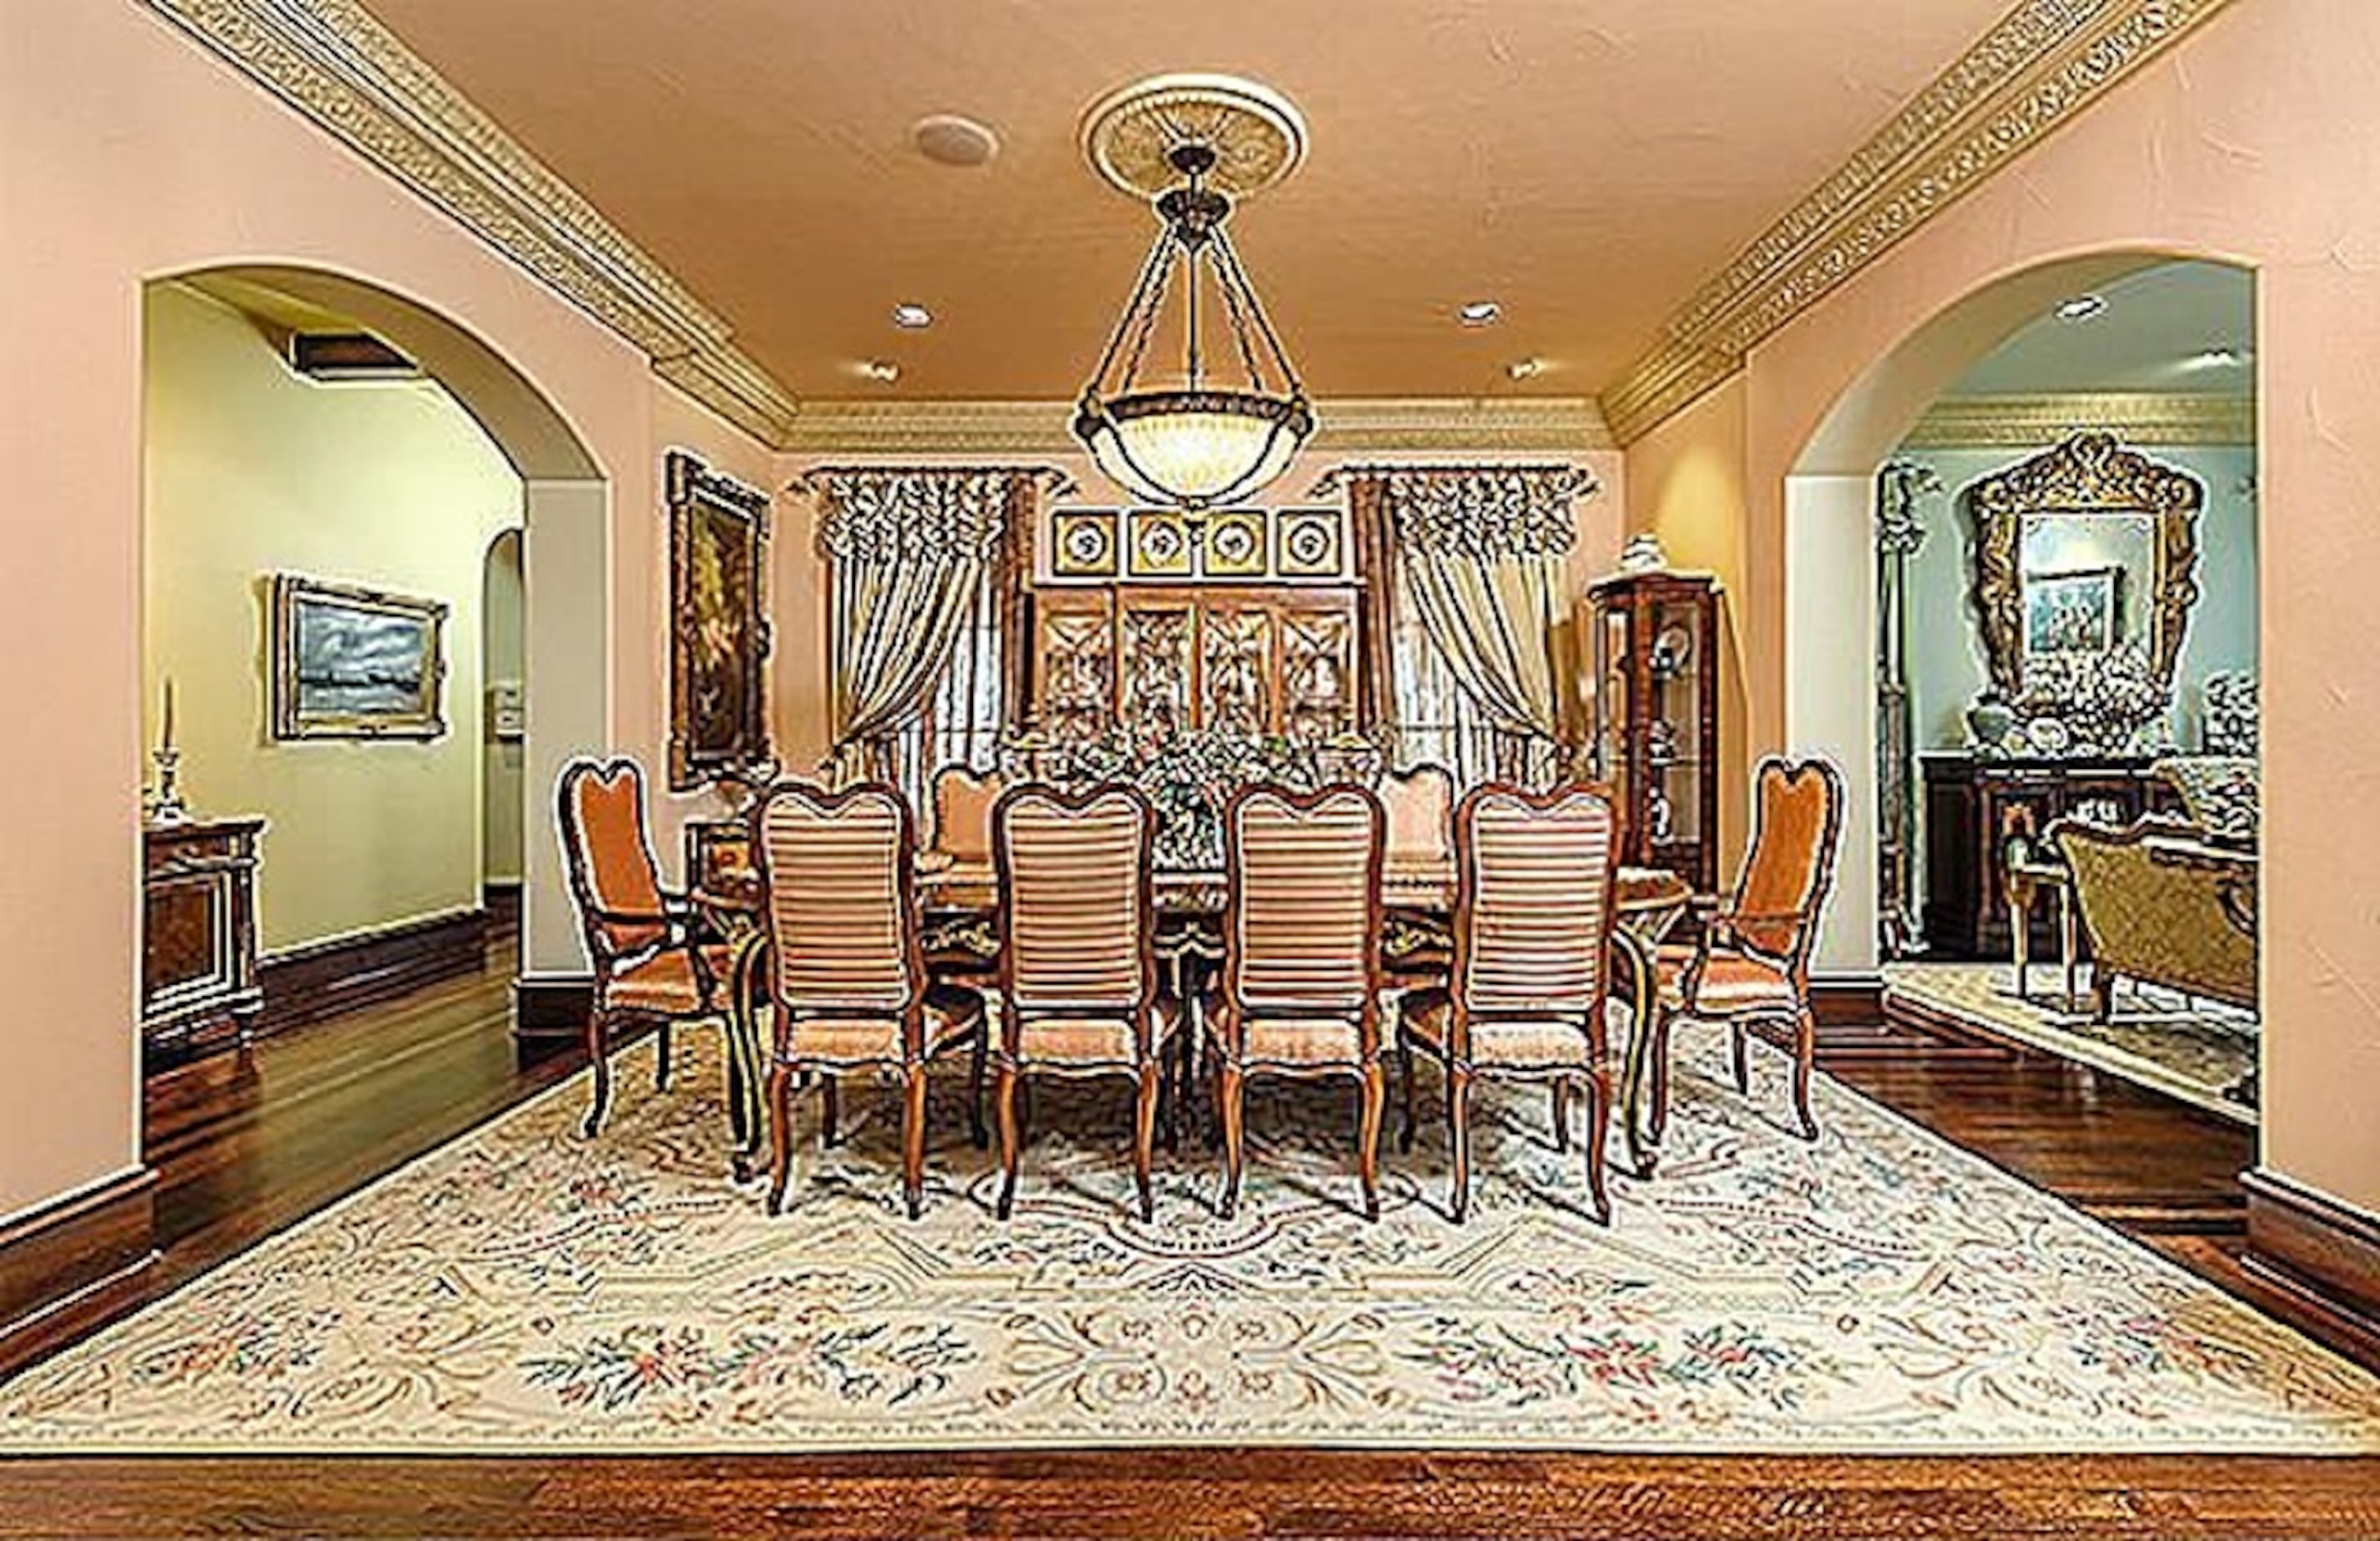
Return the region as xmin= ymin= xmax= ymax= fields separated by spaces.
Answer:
xmin=272 ymin=572 xmax=447 ymax=738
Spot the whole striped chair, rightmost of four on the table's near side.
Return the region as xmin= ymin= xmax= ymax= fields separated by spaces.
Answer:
xmin=1397 ymin=784 xmax=1619 ymax=1222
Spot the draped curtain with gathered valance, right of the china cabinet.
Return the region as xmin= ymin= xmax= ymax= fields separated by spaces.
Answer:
xmin=1350 ymin=467 xmax=1595 ymax=781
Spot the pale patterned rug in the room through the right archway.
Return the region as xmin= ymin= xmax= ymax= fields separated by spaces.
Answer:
xmin=1885 ymin=963 xmax=2259 ymax=1124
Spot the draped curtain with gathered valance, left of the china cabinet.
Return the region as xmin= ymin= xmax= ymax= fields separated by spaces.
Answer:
xmin=806 ymin=469 xmax=1035 ymax=781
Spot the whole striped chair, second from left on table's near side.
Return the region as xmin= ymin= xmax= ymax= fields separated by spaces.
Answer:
xmin=993 ymin=784 xmax=1173 ymax=1219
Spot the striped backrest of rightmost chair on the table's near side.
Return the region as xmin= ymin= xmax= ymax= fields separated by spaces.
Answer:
xmin=1455 ymin=781 xmax=1619 ymax=1034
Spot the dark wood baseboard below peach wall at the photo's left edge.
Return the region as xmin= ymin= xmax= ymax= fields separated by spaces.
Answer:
xmin=0 ymin=1167 xmax=157 ymax=1377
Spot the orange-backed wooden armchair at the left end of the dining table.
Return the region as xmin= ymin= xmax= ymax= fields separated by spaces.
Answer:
xmin=555 ymin=755 xmax=750 ymax=1164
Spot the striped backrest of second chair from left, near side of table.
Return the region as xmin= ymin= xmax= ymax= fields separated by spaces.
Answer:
xmin=993 ymin=784 xmax=1157 ymax=1027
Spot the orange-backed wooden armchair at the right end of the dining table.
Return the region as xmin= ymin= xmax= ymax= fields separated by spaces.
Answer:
xmin=1651 ymin=755 xmax=1844 ymax=1138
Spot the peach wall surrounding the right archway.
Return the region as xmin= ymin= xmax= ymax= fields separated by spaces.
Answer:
xmin=1630 ymin=0 xmax=2380 ymax=1208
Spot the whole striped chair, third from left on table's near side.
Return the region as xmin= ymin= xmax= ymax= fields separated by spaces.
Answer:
xmin=1214 ymin=786 xmax=1385 ymax=1219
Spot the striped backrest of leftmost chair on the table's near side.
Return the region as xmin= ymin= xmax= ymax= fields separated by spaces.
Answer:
xmin=755 ymin=781 xmax=925 ymax=1017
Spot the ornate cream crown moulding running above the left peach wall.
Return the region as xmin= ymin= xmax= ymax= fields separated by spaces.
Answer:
xmin=143 ymin=0 xmax=795 ymax=446
